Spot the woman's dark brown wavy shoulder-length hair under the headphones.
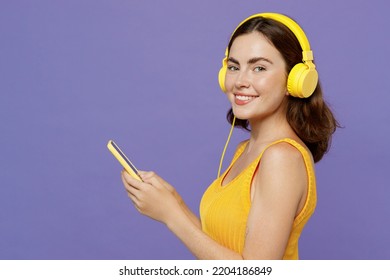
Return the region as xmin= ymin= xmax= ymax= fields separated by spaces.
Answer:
xmin=227 ymin=16 xmax=339 ymax=162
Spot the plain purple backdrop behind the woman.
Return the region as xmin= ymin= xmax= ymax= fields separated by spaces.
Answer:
xmin=0 ymin=0 xmax=390 ymax=259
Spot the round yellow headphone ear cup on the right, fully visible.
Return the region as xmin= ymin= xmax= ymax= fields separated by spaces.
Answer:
xmin=287 ymin=63 xmax=318 ymax=98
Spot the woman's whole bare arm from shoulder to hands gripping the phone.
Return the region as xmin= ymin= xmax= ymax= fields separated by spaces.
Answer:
xmin=122 ymin=144 xmax=306 ymax=259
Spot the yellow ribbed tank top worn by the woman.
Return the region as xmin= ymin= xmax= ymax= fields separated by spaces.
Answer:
xmin=200 ymin=138 xmax=317 ymax=259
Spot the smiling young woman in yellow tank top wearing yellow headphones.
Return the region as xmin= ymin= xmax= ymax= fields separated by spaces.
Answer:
xmin=122 ymin=14 xmax=337 ymax=259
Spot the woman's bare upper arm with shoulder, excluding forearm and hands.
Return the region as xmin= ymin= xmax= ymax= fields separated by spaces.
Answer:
xmin=243 ymin=143 xmax=307 ymax=259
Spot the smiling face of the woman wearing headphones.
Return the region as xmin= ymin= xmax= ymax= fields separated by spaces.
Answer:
xmin=225 ymin=32 xmax=288 ymax=122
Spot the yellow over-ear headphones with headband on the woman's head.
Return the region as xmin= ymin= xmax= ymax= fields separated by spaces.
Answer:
xmin=218 ymin=13 xmax=318 ymax=98
